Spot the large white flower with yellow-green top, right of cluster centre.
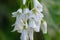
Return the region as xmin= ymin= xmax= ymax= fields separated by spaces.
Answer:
xmin=28 ymin=8 xmax=44 ymax=32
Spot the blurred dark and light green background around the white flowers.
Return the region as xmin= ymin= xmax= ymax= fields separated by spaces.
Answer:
xmin=0 ymin=0 xmax=60 ymax=40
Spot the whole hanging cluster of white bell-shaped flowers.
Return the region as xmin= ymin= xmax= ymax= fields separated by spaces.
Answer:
xmin=12 ymin=0 xmax=47 ymax=40
